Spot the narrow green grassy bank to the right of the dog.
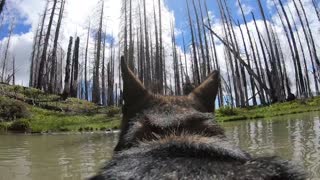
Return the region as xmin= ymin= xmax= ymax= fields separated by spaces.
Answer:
xmin=216 ymin=97 xmax=320 ymax=121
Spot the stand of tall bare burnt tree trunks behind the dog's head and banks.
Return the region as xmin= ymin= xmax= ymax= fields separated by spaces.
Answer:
xmin=0 ymin=0 xmax=320 ymax=107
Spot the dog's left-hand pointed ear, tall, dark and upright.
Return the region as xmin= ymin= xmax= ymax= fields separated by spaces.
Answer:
xmin=121 ymin=56 xmax=149 ymax=106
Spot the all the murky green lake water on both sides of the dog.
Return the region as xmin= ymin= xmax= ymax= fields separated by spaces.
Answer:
xmin=0 ymin=112 xmax=320 ymax=180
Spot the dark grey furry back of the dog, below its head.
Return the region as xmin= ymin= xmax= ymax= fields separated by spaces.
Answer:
xmin=95 ymin=137 xmax=304 ymax=179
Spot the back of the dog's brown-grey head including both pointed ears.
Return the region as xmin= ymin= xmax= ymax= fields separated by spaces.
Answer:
xmin=115 ymin=58 xmax=223 ymax=151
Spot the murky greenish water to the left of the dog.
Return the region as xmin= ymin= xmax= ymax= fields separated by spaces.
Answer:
xmin=0 ymin=134 xmax=117 ymax=180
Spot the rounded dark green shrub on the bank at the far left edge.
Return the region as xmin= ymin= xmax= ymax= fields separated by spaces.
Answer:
xmin=0 ymin=97 xmax=29 ymax=121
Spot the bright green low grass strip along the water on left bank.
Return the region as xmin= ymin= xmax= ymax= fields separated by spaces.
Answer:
xmin=0 ymin=100 xmax=121 ymax=133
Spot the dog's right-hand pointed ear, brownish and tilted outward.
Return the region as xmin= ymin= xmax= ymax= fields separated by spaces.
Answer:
xmin=188 ymin=71 xmax=220 ymax=112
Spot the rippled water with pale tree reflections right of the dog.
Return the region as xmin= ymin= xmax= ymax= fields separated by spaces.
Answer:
xmin=223 ymin=112 xmax=320 ymax=179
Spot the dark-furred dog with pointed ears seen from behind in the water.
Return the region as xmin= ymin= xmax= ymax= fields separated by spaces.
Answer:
xmin=92 ymin=58 xmax=305 ymax=180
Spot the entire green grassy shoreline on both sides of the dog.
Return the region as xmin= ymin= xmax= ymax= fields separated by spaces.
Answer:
xmin=0 ymin=85 xmax=320 ymax=133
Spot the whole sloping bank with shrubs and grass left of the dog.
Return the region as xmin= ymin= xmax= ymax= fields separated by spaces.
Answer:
xmin=0 ymin=85 xmax=121 ymax=133
